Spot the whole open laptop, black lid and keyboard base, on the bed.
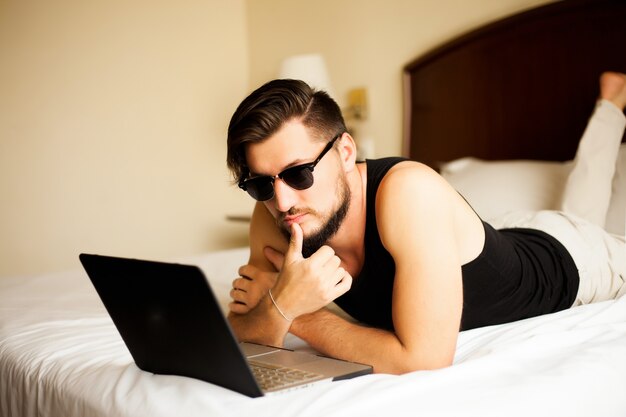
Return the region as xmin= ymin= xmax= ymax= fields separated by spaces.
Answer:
xmin=80 ymin=254 xmax=372 ymax=397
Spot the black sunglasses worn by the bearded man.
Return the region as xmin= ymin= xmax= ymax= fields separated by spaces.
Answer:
xmin=239 ymin=133 xmax=343 ymax=201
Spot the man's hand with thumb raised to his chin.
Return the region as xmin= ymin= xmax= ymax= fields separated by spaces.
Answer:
xmin=265 ymin=223 xmax=352 ymax=318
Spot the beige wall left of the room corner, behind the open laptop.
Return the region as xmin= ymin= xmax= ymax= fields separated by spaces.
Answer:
xmin=0 ymin=0 xmax=251 ymax=276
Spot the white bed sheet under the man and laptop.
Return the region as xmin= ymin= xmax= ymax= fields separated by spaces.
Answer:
xmin=0 ymin=248 xmax=626 ymax=417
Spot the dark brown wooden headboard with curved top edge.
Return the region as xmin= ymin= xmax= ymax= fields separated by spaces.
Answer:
xmin=403 ymin=0 xmax=626 ymax=168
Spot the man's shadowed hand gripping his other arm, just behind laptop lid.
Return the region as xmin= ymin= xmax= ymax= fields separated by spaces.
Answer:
xmin=228 ymin=264 xmax=278 ymax=314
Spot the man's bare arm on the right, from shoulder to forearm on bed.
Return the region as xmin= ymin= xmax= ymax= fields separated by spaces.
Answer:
xmin=291 ymin=166 xmax=467 ymax=374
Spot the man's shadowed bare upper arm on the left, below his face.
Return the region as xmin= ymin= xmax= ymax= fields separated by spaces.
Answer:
xmin=248 ymin=203 xmax=289 ymax=269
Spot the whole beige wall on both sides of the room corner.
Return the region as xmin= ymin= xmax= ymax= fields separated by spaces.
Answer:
xmin=0 ymin=0 xmax=550 ymax=277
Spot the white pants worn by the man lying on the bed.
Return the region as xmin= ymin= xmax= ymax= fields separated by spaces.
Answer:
xmin=491 ymin=100 xmax=626 ymax=305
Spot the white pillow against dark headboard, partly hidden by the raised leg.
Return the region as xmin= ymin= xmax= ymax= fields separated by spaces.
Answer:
xmin=441 ymin=144 xmax=626 ymax=236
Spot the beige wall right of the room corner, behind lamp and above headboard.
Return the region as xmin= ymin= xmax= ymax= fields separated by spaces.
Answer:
xmin=247 ymin=0 xmax=551 ymax=157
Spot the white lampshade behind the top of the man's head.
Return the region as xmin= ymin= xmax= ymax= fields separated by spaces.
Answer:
xmin=278 ymin=54 xmax=334 ymax=97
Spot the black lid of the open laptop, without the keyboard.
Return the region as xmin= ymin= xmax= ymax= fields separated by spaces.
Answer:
xmin=80 ymin=254 xmax=263 ymax=397
